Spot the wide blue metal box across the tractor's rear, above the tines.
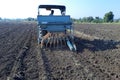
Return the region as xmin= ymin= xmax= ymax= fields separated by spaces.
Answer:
xmin=37 ymin=15 xmax=72 ymax=32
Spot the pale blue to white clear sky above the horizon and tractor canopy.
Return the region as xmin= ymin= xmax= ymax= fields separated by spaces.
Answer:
xmin=0 ymin=0 xmax=120 ymax=19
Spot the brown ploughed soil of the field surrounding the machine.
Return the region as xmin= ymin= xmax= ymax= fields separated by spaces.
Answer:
xmin=0 ymin=22 xmax=120 ymax=80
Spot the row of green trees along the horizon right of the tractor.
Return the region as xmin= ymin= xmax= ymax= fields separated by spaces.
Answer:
xmin=72 ymin=11 xmax=120 ymax=23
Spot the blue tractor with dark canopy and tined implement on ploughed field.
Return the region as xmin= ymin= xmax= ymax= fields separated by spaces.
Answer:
xmin=37 ymin=5 xmax=76 ymax=51
